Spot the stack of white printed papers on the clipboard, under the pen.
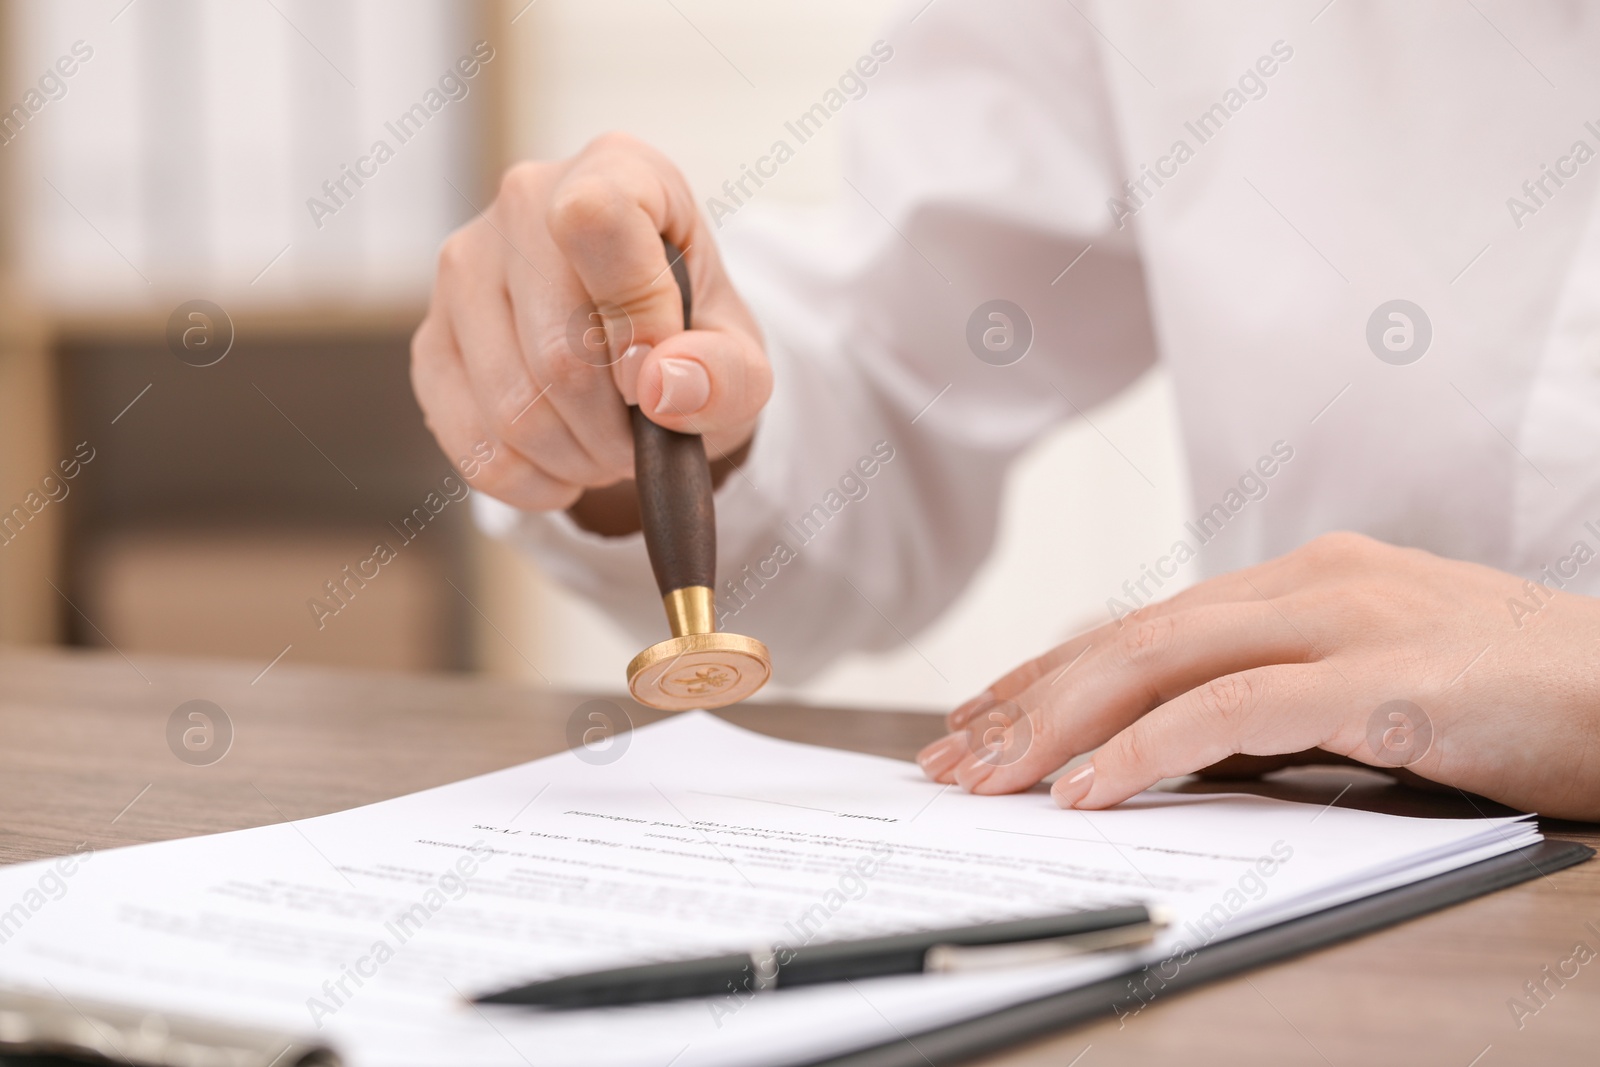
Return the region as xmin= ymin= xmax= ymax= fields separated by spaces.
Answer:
xmin=0 ymin=712 xmax=1539 ymax=1067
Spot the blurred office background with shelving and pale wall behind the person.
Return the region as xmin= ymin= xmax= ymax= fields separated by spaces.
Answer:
xmin=0 ymin=0 xmax=1187 ymax=710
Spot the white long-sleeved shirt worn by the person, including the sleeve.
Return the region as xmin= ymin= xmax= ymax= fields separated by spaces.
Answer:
xmin=480 ymin=0 xmax=1600 ymax=681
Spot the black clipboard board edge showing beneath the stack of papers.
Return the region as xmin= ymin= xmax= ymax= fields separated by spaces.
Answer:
xmin=802 ymin=840 xmax=1595 ymax=1067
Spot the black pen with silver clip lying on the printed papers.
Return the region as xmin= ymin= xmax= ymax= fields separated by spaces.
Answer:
xmin=474 ymin=904 xmax=1166 ymax=1008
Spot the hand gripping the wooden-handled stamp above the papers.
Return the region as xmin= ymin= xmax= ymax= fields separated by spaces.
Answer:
xmin=411 ymin=134 xmax=773 ymax=510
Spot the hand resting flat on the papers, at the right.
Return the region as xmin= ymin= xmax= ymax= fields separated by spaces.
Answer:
xmin=918 ymin=533 xmax=1600 ymax=819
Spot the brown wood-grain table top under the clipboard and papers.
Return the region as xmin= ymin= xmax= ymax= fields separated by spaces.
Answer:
xmin=0 ymin=649 xmax=1600 ymax=1067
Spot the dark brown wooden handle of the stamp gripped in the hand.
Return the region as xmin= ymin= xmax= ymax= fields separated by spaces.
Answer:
xmin=629 ymin=238 xmax=717 ymax=597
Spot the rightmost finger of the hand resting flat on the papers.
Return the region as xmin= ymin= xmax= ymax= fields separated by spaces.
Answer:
xmin=1050 ymin=664 xmax=1333 ymax=808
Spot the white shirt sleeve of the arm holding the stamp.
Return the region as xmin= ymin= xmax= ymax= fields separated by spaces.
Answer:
xmin=478 ymin=0 xmax=1155 ymax=683
